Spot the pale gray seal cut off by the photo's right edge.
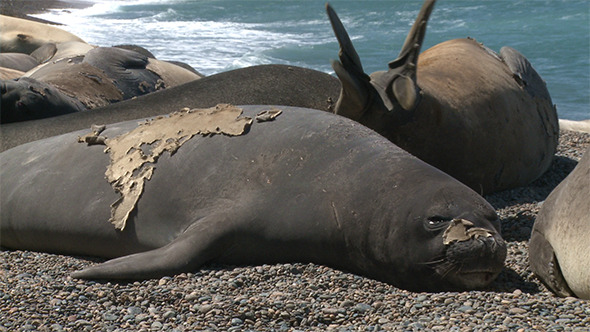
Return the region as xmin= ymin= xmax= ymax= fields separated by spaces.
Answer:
xmin=529 ymin=148 xmax=590 ymax=299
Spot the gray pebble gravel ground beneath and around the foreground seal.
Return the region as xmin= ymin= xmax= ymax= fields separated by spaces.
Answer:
xmin=0 ymin=132 xmax=590 ymax=331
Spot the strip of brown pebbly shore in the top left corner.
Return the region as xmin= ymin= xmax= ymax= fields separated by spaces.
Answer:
xmin=0 ymin=0 xmax=93 ymax=25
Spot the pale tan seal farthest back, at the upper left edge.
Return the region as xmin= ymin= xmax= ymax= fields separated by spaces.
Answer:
xmin=0 ymin=15 xmax=84 ymax=54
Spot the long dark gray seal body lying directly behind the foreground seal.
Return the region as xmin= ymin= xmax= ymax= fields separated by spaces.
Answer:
xmin=0 ymin=65 xmax=340 ymax=151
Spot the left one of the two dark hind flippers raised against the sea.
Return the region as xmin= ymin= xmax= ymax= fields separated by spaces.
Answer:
xmin=326 ymin=4 xmax=375 ymax=120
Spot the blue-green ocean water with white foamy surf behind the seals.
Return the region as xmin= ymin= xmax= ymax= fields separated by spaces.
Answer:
xmin=36 ymin=0 xmax=590 ymax=120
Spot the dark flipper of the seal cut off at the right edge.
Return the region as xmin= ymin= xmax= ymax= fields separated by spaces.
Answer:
xmin=529 ymin=230 xmax=576 ymax=297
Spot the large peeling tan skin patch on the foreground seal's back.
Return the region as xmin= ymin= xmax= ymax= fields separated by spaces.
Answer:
xmin=81 ymin=104 xmax=252 ymax=230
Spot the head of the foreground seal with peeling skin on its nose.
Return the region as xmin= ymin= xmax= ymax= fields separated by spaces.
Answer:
xmin=400 ymin=183 xmax=506 ymax=290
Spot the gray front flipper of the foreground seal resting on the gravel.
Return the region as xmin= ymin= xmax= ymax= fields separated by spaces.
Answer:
xmin=72 ymin=216 xmax=234 ymax=280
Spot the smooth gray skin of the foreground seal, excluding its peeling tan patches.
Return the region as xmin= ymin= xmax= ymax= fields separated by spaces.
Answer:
xmin=0 ymin=106 xmax=506 ymax=291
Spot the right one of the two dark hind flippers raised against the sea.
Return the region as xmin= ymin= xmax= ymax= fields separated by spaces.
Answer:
xmin=371 ymin=0 xmax=436 ymax=111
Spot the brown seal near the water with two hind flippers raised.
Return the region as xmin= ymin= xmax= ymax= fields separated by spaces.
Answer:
xmin=328 ymin=0 xmax=559 ymax=194
